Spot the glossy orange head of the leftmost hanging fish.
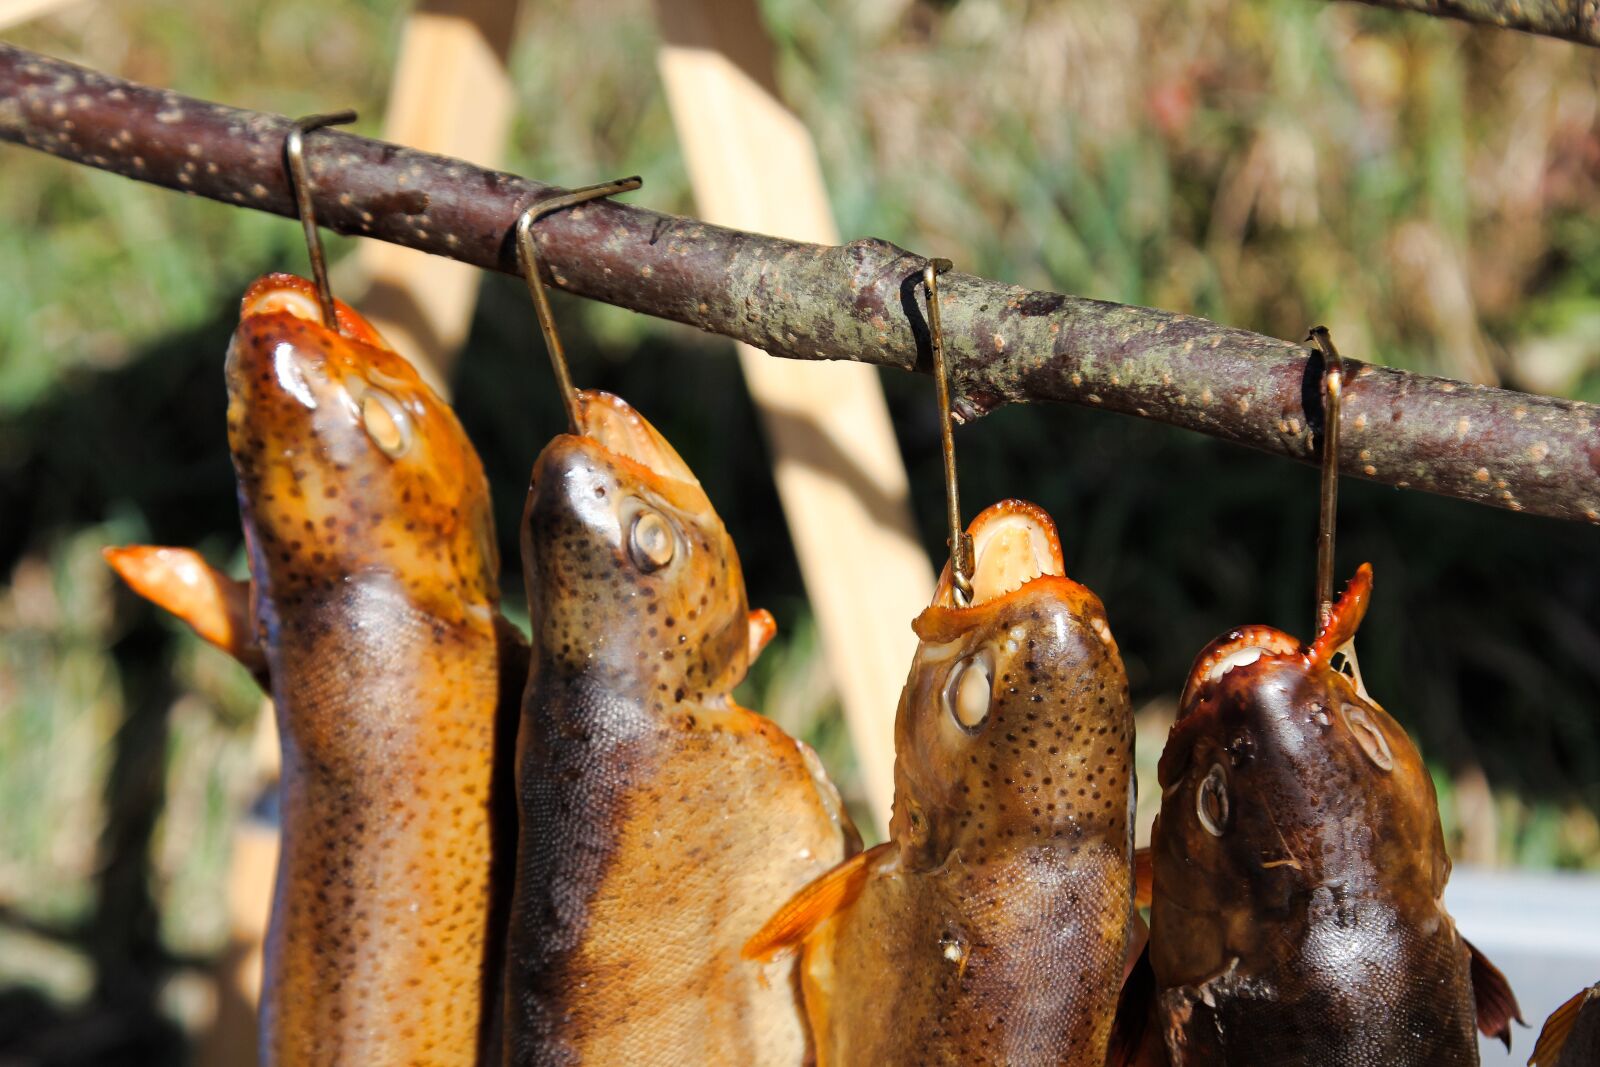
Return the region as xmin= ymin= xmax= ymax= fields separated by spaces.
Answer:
xmin=226 ymin=274 xmax=499 ymax=619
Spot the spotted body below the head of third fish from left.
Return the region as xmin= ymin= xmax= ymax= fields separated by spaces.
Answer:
xmin=806 ymin=845 xmax=1131 ymax=1067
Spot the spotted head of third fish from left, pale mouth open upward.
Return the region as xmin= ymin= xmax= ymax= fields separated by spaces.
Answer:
xmin=890 ymin=501 xmax=1133 ymax=865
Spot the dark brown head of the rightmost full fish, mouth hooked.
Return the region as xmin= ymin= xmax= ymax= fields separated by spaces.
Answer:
xmin=1155 ymin=565 xmax=1450 ymax=936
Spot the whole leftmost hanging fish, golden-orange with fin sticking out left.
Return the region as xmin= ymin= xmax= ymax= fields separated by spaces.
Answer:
xmin=107 ymin=274 xmax=526 ymax=1065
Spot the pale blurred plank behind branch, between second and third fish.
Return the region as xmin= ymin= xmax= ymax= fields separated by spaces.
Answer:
xmin=656 ymin=0 xmax=933 ymax=830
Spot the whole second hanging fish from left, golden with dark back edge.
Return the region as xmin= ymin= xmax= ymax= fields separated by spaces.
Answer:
xmin=506 ymin=392 xmax=859 ymax=1064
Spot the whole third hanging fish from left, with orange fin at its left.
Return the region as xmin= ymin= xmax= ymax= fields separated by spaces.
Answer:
xmin=746 ymin=501 xmax=1134 ymax=1067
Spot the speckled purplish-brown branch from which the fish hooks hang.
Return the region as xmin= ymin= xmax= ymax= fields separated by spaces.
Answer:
xmin=0 ymin=43 xmax=1600 ymax=523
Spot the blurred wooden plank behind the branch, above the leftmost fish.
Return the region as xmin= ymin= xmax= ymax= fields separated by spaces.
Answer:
xmin=344 ymin=0 xmax=517 ymax=394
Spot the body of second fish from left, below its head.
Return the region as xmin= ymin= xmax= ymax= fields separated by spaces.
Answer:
xmin=507 ymin=700 xmax=845 ymax=1065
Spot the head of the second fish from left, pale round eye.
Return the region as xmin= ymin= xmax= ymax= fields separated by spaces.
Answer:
xmin=522 ymin=390 xmax=752 ymax=707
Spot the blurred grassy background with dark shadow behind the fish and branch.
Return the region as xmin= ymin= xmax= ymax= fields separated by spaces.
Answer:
xmin=0 ymin=0 xmax=1600 ymax=1062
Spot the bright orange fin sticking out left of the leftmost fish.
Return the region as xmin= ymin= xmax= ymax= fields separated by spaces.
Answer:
xmin=101 ymin=544 xmax=267 ymax=678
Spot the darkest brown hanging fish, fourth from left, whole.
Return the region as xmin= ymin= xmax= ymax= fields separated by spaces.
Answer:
xmin=1149 ymin=565 xmax=1520 ymax=1067
